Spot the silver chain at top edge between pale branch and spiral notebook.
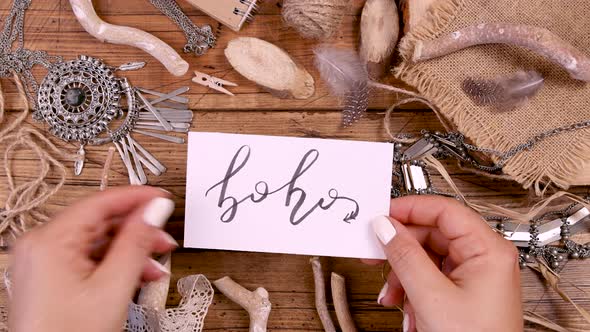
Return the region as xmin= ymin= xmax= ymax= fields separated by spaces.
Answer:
xmin=150 ymin=0 xmax=217 ymax=55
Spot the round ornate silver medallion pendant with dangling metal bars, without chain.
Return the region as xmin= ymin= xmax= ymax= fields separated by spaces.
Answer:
xmin=34 ymin=55 xmax=193 ymax=185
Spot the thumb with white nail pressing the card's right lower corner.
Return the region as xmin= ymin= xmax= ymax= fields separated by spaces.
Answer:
xmin=371 ymin=217 xmax=455 ymax=306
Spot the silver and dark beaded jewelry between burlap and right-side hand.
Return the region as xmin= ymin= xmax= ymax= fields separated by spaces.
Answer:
xmin=391 ymin=128 xmax=590 ymax=270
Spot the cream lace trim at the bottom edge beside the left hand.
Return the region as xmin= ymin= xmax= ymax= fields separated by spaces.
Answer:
xmin=125 ymin=274 xmax=214 ymax=332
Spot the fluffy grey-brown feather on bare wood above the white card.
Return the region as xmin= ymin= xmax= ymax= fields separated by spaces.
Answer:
xmin=314 ymin=45 xmax=369 ymax=126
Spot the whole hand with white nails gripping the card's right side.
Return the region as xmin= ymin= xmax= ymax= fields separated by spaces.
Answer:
xmin=372 ymin=196 xmax=523 ymax=332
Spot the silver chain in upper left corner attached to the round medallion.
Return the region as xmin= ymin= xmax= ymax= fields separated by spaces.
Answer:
xmin=0 ymin=0 xmax=61 ymax=108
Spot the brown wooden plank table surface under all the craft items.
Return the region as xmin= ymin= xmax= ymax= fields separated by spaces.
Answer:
xmin=0 ymin=0 xmax=590 ymax=331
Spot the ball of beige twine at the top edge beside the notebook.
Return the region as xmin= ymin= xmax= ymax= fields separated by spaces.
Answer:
xmin=282 ymin=0 xmax=350 ymax=39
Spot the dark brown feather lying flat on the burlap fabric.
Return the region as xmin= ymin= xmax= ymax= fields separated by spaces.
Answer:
xmin=462 ymin=70 xmax=544 ymax=111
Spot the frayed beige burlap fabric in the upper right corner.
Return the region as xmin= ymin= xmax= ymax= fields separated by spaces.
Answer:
xmin=395 ymin=0 xmax=590 ymax=193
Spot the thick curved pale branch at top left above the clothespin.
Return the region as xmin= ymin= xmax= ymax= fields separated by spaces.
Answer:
xmin=70 ymin=0 xmax=189 ymax=76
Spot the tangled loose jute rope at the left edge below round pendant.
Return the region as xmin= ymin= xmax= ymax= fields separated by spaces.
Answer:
xmin=0 ymin=75 xmax=77 ymax=246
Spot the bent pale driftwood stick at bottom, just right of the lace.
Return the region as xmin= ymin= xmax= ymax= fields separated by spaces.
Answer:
xmin=213 ymin=277 xmax=271 ymax=332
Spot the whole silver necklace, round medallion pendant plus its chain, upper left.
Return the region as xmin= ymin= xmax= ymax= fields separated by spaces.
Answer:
xmin=0 ymin=0 xmax=193 ymax=184
